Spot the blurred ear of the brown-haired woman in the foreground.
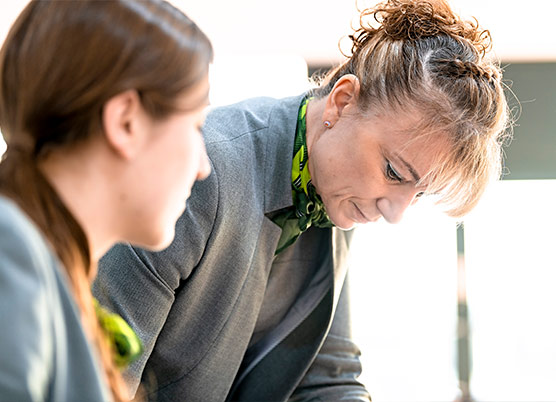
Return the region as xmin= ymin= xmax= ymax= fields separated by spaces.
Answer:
xmin=102 ymin=90 xmax=145 ymax=159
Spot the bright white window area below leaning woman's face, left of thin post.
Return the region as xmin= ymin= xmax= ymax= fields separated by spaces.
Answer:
xmin=349 ymin=200 xmax=459 ymax=402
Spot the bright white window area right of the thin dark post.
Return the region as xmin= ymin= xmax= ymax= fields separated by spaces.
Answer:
xmin=465 ymin=180 xmax=556 ymax=401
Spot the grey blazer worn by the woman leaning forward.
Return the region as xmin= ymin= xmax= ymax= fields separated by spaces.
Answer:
xmin=94 ymin=96 xmax=370 ymax=401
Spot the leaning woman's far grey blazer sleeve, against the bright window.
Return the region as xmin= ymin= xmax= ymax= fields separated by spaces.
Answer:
xmin=289 ymin=276 xmax=371 ymax=402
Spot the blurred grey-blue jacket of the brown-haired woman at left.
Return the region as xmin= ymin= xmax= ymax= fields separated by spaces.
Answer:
xmin=0 ymin=196 xmax=111 ymax=402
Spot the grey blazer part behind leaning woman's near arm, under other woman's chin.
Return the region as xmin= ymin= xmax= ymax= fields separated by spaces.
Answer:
xmin=93 ymin=169 xmax=218 ymax=395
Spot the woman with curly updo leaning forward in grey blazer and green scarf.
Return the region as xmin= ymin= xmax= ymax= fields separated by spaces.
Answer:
xmin=94 ymin=0 xmax=508 ymax=402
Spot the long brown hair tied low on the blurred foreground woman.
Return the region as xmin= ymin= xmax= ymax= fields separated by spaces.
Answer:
xmin=0 ymin=0 xmax=212 ymax=400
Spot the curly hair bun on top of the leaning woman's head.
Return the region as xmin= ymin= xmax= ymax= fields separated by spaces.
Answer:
xmin=350 ymin=0 xmax=491 ymax=54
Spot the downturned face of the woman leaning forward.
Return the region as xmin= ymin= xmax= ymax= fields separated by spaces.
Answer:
xmin=308 ymin=107 xmax=447 ymax=229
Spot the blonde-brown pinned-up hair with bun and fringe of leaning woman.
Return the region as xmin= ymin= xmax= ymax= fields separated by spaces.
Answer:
xmin=314 ymin=0 xmax=509 ymax=216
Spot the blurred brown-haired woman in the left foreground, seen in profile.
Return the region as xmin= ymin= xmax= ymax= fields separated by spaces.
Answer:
xmin=0 ymin=0 xmax=212 ymax=401
